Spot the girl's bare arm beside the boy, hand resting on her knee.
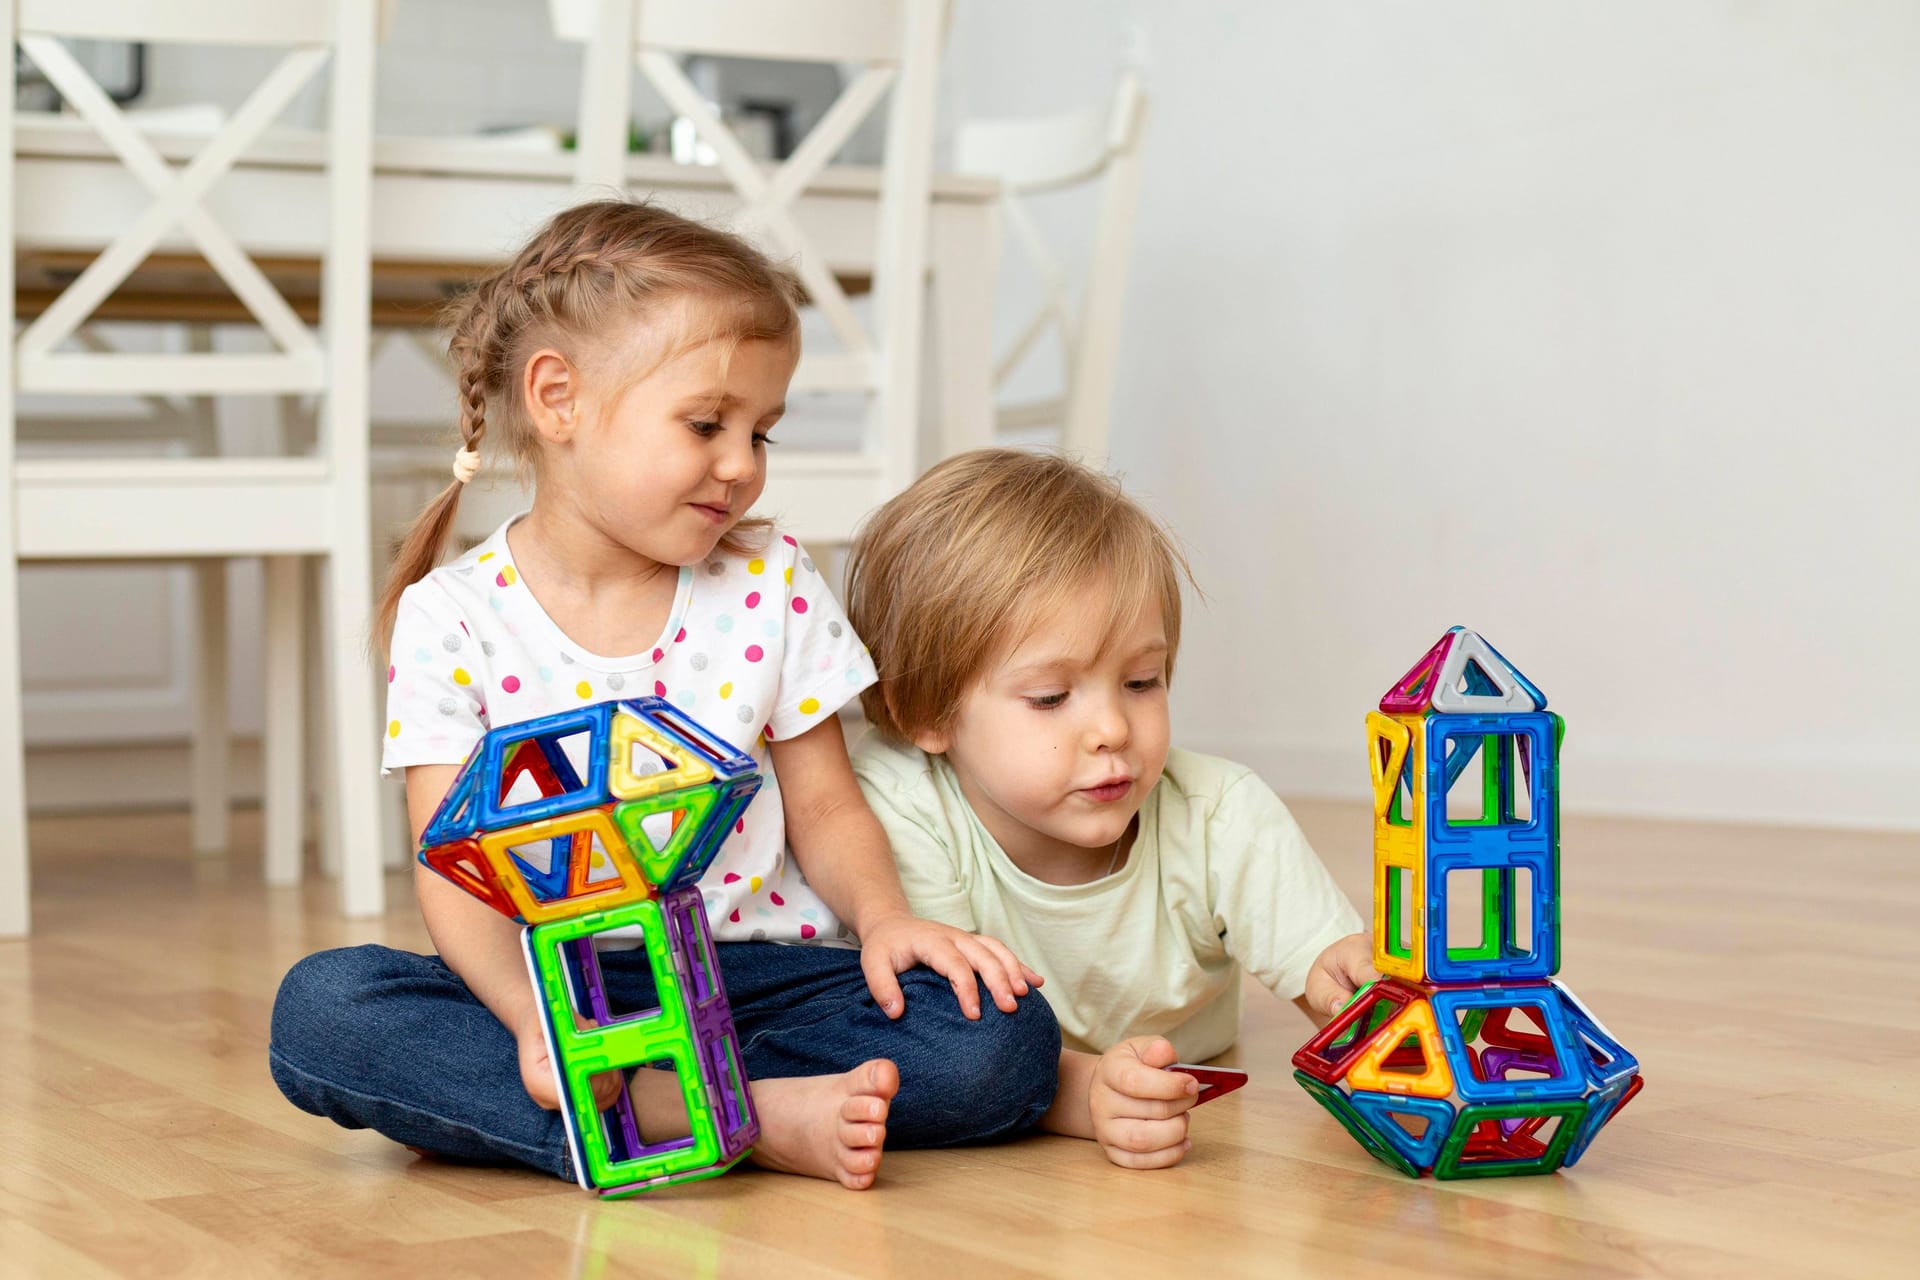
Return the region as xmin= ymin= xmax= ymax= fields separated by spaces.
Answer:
xmin=772 ymin=716 xmax=1041 ymax=1017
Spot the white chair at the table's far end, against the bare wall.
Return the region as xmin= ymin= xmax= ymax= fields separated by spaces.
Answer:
xmin=943 ymin=67 xmax=1146 ymax=466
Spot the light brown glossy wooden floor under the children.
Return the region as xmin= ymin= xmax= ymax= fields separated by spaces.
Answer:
xmin=0 ymin=804 xmax=1920 ymax=1280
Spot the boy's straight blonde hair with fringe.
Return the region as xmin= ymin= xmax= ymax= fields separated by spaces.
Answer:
xmin=847 ymin=449 xmax=1192 ymax=743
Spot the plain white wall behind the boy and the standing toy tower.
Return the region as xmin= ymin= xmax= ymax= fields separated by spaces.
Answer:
xmin=950 ymin=0 xmax=1920 ymax=827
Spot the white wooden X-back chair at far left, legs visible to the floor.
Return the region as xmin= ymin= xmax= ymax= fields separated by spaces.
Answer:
xmin=0 ymin=0 xmax=382 ymax=935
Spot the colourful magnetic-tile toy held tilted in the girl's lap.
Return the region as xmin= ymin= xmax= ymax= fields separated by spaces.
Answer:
xmin=420 ymin=699 xmax=760 ymax=1196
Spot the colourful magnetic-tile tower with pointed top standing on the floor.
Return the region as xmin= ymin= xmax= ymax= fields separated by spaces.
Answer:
xmin=1294 ymin=628 xmax=1642 ymax=1178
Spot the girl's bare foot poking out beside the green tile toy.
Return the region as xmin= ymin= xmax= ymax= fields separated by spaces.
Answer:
xmin=753 ymin=1057 xmax=900 ymax=1192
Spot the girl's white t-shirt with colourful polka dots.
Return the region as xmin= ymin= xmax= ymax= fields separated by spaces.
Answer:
xmin=380 ymin=520 xmax=874 ymax=942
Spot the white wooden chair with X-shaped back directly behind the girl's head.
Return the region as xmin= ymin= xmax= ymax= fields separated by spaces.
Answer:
xmin=555 ymin=0 xmax=947 ymax=539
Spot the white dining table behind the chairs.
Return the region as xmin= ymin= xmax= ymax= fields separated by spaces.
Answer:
xmin=13 ymin=113 xmax=1000 ymax=475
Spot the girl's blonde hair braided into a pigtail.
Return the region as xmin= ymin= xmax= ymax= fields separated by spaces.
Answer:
xmin=372 ymin=200 xmax=803 ymax=649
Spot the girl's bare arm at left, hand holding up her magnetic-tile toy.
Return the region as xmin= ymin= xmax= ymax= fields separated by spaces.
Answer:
xmin=407 ymin=764 xmax=618 ymax=1111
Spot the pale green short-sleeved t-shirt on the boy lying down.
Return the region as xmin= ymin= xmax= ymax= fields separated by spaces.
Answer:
xmin=854 ymin=733 xmax=1361 ymax=1061
